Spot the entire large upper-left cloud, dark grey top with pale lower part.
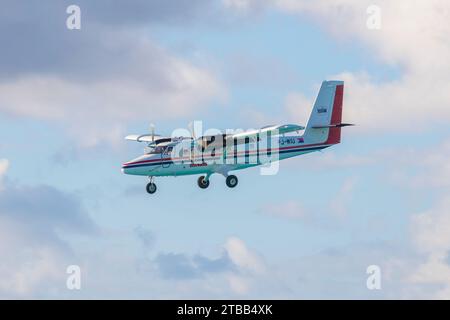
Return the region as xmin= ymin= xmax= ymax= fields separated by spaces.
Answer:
xmin=0 ymin=1 xmax=225 ymax=147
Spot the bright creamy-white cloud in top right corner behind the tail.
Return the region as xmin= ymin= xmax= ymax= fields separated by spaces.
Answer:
xmin=273 ymin=0 xmax=450 ymax=131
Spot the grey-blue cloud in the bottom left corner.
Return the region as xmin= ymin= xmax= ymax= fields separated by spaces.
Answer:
xmin=0 ymin=168 xmax=97 ymax=298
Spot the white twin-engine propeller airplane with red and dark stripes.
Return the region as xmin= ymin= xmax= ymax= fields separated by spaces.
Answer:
xmin=122 ymin=81 xmax=353 ymax=194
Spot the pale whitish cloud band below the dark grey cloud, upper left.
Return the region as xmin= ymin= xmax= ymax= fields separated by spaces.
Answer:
xmin=0 ymin=58 xmax=224 ymax=146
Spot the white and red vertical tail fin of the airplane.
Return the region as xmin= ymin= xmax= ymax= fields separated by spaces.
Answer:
xmin=303 ymin=81 xmax=349 ymax=144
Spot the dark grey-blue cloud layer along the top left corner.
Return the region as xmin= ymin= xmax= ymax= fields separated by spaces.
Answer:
xmin=0 ymin=0 xmax=220 ymax=80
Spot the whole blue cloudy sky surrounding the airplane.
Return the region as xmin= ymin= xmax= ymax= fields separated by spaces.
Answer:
xmin=0 ymin=0 xmax=450 ymax=299
